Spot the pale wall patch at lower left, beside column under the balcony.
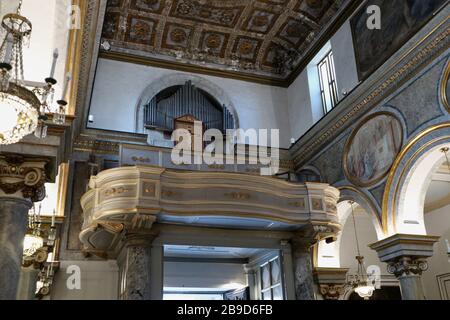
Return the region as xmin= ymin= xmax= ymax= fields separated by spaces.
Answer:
xmin=51 ymin=260 xmax=119 ymax=300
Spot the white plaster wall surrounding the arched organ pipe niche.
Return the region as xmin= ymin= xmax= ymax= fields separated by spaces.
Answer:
xmin=88 ymin=59 xmax=291 ymax=147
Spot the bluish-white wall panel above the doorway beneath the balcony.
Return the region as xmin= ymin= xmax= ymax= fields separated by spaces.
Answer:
xmin=164 ymin=262 xmax=247 ymax=289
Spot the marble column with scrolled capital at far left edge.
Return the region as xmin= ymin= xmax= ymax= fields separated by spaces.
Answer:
xmin=0 ymin=155 xmax=47 ymax=300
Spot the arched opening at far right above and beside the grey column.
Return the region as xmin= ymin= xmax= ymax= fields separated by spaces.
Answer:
xmin=397 ymin=143 xmax=450 ymax=300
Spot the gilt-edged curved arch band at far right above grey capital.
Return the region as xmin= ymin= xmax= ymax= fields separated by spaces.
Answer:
xmin=382 ymin=122 xmax=450 ymax=237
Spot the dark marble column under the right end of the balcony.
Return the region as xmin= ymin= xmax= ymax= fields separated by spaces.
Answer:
xmin=291 ymin=239 xmax=315 ymax=300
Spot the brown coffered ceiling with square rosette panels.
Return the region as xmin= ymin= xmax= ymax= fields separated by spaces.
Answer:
xmin=102 ymin=0 xmax=349 ymax=85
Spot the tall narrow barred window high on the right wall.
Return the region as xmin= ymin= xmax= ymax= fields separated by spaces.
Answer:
xmin=317 ymin=51 xmax=338 ymax=114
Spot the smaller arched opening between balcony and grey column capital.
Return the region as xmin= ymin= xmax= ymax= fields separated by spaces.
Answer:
xmin=316 ymin=196 xmax=401 ymax=300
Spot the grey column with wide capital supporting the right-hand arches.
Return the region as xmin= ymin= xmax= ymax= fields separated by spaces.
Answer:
xmin=370 ymin=234 xmax=439 ymax=300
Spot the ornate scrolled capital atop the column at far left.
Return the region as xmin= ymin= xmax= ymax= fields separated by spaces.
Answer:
xmin=0 ymin=155 xmax=48 ymax=202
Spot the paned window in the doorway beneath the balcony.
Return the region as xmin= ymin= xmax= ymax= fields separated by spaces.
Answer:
xmin=261 ymin=257 xmax=284 ymax=300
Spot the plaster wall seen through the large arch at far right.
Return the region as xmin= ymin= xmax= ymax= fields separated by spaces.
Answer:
xmin=422 ymin=205 xmax=450 ymax=300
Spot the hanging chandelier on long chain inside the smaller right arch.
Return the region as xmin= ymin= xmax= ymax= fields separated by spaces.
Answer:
xmin=349 ymin=201 xmax=375 ymax=300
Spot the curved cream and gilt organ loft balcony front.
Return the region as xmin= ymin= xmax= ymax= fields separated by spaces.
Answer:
xmin=80 ymin=166 xmax=340 ymax=257
